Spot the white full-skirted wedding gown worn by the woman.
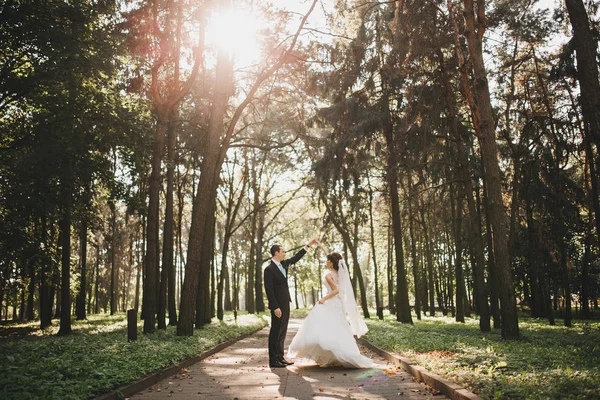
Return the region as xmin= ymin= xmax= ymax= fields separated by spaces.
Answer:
xmin=288 ymin=272 xmax=375 ymax=368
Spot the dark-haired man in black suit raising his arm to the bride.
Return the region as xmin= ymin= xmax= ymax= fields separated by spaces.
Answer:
xmin=264 ymin=239 xmax=318 ymax=368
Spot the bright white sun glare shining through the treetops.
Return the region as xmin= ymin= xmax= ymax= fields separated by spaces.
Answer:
xmin=206 ymin=8 xmax=264 ymax=66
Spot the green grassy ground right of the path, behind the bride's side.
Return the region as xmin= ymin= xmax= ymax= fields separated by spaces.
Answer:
xmin=365 ymin=316 xmax=600 ymax=400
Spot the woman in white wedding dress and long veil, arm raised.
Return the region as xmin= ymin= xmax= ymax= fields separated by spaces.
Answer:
xmin=288 ymin=243 xmax=375 ymax=368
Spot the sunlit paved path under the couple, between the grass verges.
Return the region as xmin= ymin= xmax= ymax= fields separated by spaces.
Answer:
xmin=131 ymin=319 xmax=446 ymax=400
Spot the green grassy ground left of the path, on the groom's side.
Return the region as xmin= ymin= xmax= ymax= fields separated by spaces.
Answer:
xmin=0 ymin=314 xmax=267 ymax=400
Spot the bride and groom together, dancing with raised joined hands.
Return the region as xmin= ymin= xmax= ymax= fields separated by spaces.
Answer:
xmin=264 ymin=239 xmax=374 ymax=368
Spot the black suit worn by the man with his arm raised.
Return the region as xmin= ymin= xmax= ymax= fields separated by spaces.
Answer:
xmin=264 ymin=249 xmax=306 ymax=365
